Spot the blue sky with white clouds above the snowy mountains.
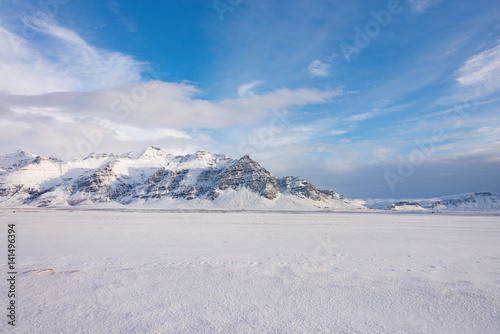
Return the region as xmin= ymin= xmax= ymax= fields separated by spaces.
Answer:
xmin=0 ymin=0 xmax=500 ymax=198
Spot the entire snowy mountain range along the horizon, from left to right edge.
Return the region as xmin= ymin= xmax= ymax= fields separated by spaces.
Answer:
xmin=0 ymin=147 xmax=500 ymax=211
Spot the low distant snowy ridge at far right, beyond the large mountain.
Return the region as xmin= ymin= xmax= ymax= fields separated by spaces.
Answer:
xmin=354 ymin=192 xmax=500 ymax=212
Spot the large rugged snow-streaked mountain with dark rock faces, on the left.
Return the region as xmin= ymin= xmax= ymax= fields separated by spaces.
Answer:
xmin=0 ymin=147 xmax=360 ymax=206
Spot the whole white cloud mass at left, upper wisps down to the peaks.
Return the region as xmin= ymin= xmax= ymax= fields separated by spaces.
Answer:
xmin=0 ymin=20 xmax=345 ymax=157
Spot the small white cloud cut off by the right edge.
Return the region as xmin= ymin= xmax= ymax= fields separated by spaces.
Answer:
xmin=457 ymin=45 xmax=500 ymax=90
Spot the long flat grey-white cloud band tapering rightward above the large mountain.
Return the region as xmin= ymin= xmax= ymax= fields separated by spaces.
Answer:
xmin=0 ymin=81 xmax=343 ymax=129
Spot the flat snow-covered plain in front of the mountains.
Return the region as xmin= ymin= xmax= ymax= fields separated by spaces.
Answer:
xmin=0 ymin=208 xmax=500 ymax=333
